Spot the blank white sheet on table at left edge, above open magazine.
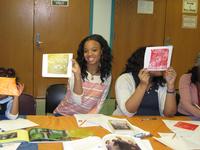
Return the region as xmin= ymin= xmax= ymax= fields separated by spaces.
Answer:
xmin=0 ymin=118 xmax=38 ymax=131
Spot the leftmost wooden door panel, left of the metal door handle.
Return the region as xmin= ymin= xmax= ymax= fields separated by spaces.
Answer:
xmin=0 ymin=0 xmax=34 ymax=94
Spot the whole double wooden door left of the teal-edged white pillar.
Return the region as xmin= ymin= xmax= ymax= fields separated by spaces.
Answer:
xmin=0 ymin=0 xmax=90 ymax=97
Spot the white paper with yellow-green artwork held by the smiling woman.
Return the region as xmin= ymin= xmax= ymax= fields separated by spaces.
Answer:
xmin=42 ymin=53 xmax=73 ymax=78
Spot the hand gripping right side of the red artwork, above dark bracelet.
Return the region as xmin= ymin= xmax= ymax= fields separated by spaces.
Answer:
xmin=164 ymin=67 xmax=176 ymax=88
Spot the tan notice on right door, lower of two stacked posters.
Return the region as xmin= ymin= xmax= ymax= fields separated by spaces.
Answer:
xmin=182 ymin=15 xmax=197 ymax=29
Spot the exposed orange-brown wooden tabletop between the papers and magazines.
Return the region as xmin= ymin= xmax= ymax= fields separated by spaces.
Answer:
xmin=27 ymin=116 xmax=191 ymax=150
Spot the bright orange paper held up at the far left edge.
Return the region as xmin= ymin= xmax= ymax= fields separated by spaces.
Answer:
xmin=0 ymin=77 xmax=19 ymax=96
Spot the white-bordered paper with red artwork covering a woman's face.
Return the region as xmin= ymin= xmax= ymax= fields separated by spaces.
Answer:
xmin=144 ymin=46 xmax=173 ymax=71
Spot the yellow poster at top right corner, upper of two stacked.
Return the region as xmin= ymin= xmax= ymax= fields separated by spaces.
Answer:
xmin=183 ymin=0 xmax=198 ymax=13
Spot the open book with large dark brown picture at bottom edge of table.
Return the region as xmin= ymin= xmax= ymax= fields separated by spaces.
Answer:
xmin=63 ymin=134 xmax=153 ymax=150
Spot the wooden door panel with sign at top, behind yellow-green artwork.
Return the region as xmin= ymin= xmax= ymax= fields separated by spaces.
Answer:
xmin=34 ymin=0 xmax=90 ymax=97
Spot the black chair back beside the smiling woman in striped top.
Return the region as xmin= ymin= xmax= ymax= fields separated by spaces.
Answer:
xmin=45 ymin=84 xmax=67 ymax=113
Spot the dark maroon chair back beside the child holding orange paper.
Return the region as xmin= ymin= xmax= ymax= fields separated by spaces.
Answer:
xmin=19 ymin=93 xmax=36 ymax=115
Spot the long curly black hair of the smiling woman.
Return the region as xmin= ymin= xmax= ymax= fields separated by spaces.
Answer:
xmin=76 ymin=34 xmax=112 ymax=82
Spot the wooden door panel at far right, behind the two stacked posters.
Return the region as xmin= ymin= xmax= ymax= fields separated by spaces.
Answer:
xmin=165 ymin=0 xmax=200 ymax=88
